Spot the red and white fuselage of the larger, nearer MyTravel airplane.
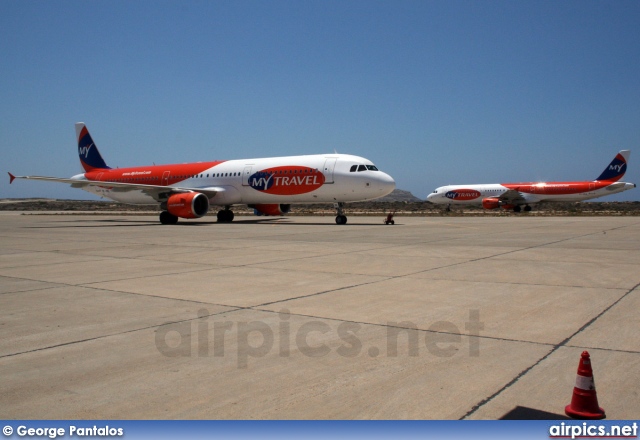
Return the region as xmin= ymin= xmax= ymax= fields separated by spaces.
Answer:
xmin=72 ymin=154 xmax=395 ymax=206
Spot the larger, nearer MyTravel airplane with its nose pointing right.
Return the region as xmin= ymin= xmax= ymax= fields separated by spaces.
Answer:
xmin=9 ymin=122 xmax=395 ymax=225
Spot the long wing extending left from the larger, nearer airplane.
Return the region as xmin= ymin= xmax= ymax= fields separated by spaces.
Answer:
xmin=9 ymin=173 xmax=225 ymax=202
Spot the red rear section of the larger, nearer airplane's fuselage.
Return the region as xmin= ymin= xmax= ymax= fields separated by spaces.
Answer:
xmin=84 ymin=160 xmax=225 ymax=186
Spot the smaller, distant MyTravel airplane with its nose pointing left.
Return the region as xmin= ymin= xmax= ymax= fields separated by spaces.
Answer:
xmin=427 ymin=150 xmax=636 ymax=212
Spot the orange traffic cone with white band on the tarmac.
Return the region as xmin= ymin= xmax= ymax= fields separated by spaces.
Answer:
xmin=564 ymin=351 xmax=606 ymax=420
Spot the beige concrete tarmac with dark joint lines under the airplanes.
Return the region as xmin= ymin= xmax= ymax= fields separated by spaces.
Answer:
xmin=0 ymin=213 xmax=640 ymax=419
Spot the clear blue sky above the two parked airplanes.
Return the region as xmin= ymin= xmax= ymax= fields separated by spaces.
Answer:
xmin=0 ymin=0 xmax=640 ymax=200
